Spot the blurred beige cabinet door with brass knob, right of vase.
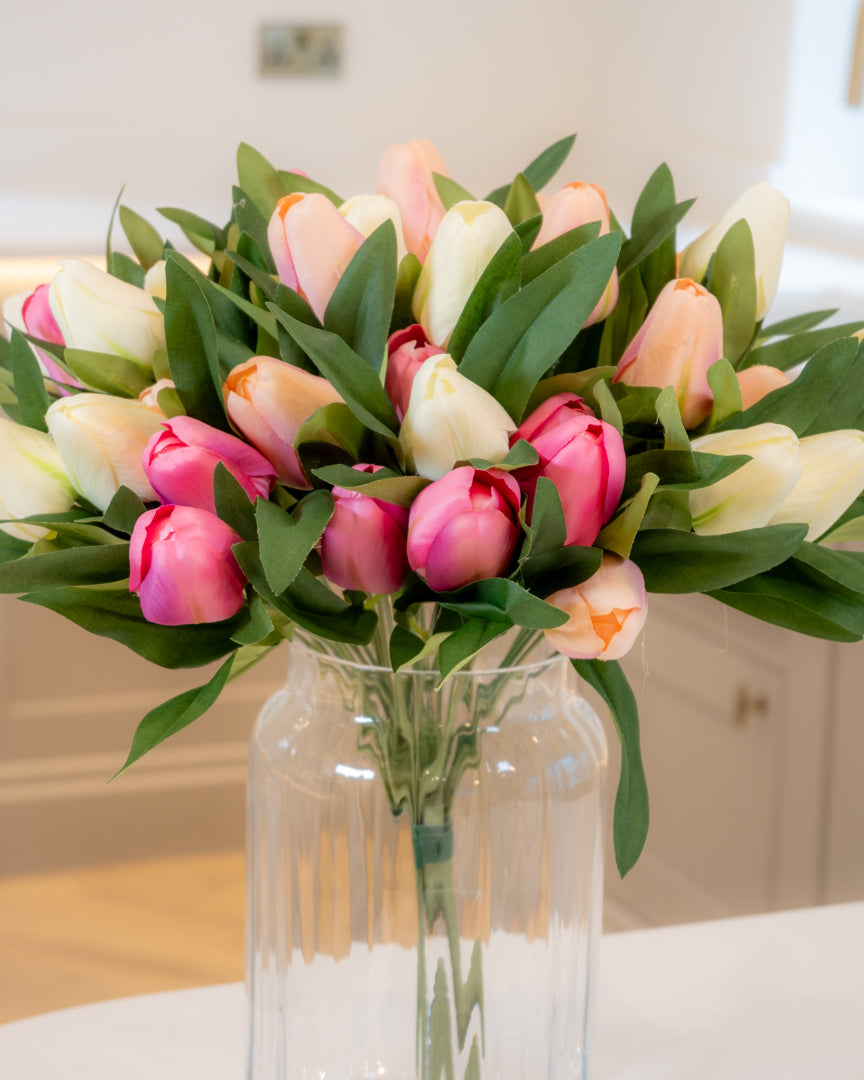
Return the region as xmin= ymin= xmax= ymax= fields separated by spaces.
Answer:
xmin=607 ymin=596 xmax=828 ymax=926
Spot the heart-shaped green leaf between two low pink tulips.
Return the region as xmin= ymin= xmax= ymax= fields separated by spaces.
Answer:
xmin=255 ymin=490 xmax=334 ymax=595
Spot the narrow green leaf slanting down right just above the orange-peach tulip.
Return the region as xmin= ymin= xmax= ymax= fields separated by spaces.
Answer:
xmin=269 ymin=303 xmax=399 ymax=435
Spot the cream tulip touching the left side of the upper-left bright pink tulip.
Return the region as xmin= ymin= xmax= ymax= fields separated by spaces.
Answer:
xmin=45 ymin=393 xmax=164 ymax=510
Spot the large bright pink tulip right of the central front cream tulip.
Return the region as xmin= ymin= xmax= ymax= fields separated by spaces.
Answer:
xmin=513 ymin=393 xmax=626 ymax=544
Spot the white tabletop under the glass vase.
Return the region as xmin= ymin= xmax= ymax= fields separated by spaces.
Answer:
xmin=0 ymin=903 xmax=864 ymax=1080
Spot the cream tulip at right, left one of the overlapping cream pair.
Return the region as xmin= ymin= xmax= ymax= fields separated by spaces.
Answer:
xmin=690 ymin=423 xmax=802 ymax=536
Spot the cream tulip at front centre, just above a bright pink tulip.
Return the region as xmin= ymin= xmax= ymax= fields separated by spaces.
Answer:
xmin=399 ymin=353 xmax=516 ymax=480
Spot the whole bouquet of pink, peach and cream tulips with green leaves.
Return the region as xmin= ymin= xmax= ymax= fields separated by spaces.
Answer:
xmin=0 ymin=132 xmax=864 ymax=873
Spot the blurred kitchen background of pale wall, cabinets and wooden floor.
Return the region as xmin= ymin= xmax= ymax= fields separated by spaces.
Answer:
xmin=0 ymin=0 xmax=864 ymax=1021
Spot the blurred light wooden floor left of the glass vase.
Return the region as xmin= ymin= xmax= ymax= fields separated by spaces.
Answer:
xmin=0 ymin=851 xmax=244 ymax=1023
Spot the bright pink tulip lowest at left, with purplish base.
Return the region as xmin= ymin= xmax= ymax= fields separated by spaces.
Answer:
xmin=129 ymin=505 xmax=246 ymax=626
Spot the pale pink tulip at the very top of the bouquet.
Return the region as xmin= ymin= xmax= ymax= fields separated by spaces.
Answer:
xmin=377 ymin=138 xmax=449 ymax=262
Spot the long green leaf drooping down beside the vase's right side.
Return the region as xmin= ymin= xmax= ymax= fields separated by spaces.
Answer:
xmin=571 ymin=660 xmax=649 ymax=877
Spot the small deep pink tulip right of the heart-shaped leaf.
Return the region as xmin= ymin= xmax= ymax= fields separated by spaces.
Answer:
xmin=320 ymin=465 xmax=408 ymax=596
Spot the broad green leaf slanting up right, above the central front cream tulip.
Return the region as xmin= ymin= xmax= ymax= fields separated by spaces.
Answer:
xmin=460 ymin=233 xmax=621 ymax=420
